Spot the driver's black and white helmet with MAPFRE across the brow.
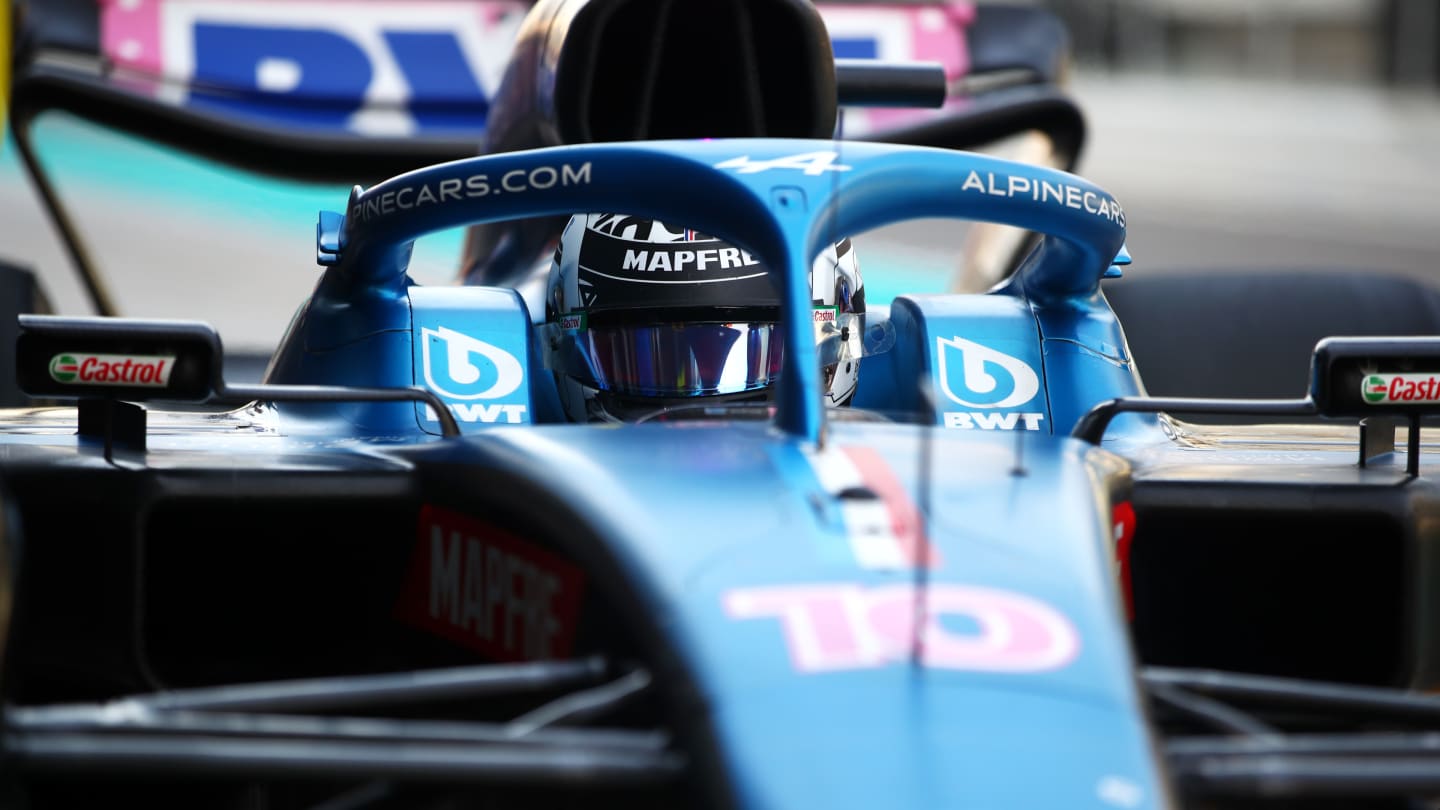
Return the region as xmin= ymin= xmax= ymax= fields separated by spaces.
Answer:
xmin=546 ymin=213 xmax=865 ymax=421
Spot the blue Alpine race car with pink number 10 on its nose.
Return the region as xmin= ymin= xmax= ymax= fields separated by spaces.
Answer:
xmin=0 ymin=0 xmax=1440 ymax=809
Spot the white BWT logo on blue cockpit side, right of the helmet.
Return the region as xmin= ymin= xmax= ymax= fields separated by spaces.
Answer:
xmin=935 ymin=337 xmax=1045 ymax=431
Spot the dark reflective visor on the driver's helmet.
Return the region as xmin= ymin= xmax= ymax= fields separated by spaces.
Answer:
xmin=566 ymin=323 xmax=783 ymax=396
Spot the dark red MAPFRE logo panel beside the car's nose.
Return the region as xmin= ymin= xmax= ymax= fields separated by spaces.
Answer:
xmin=397 ymin=506 xmax=585 ymax=662
